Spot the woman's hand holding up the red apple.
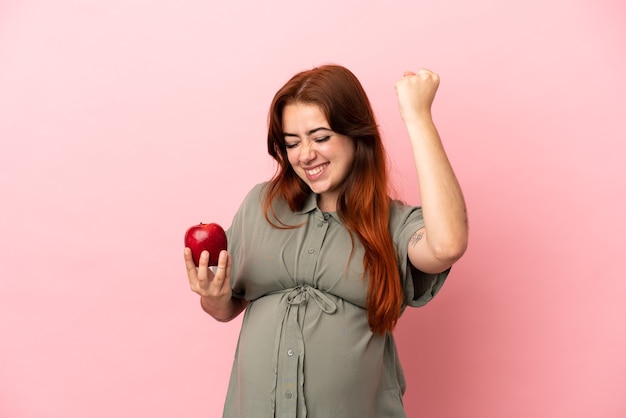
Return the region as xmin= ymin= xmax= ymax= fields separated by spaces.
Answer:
xmin=185 ymin=247 xmax=232 ymax=314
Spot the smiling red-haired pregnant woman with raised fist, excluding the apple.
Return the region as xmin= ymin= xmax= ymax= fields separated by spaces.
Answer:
xmin=185 ymin=65 xmax=467 ymax=418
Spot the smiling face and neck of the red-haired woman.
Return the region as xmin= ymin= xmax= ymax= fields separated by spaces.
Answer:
xmin=282 ymin=102 xmax=355 ymax=212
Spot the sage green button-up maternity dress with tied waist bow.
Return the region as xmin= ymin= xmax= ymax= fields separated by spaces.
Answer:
xmin=224 ymin=184 xmax=448 ymax=418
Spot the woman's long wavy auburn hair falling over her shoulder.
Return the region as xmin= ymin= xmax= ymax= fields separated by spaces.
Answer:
xmin=263 ymin=65 xmax=402 ymax=334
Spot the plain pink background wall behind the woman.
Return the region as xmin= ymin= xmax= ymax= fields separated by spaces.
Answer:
xmin=0 ymin=0 xmax=626 ymax=418
